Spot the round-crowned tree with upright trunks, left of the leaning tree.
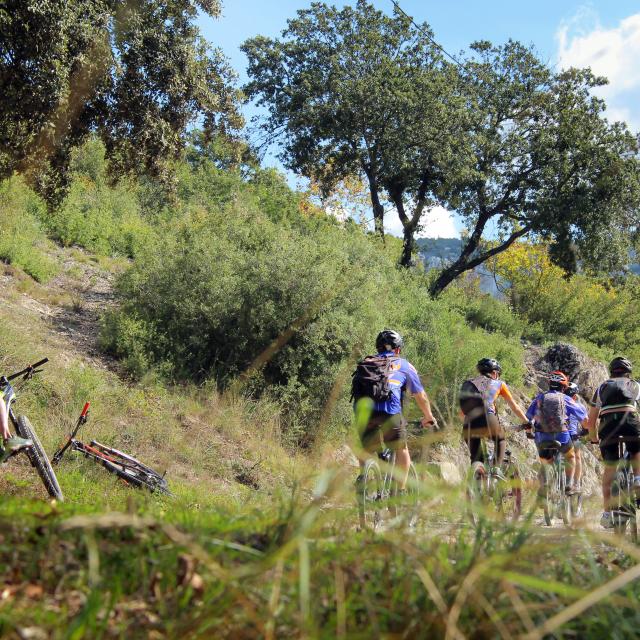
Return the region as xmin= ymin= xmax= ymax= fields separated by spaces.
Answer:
xmin=243 ymin=0 xmax=463 ymax=265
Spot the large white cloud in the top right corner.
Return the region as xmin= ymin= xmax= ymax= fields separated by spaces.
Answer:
xmin=556 ymin=9 xmax=640 ymax=130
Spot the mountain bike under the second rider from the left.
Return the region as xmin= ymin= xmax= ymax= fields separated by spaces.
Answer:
xmin=467 ymin=438 xmax=522 ymax=525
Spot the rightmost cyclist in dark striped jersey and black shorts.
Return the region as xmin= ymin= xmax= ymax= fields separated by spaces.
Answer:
xmin=588 ymin=356 xmax=640 ymax=529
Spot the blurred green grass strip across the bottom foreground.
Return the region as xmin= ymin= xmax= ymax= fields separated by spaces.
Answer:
xmin=0 ymin=471 xmax=640 ymax=638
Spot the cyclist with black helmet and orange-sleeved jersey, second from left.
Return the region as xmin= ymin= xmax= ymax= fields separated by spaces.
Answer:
xmin=460 ymin=358 xmax=528 ymax=476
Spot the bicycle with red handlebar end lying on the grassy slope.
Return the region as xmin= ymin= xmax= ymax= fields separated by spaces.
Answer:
xmin=52 ymin=402 xmax=172 ymax=496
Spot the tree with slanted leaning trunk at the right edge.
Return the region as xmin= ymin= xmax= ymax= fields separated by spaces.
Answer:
xmin=431 ymin=41 xmax=640 ymax=295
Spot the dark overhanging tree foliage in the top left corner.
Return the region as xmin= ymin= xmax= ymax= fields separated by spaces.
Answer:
xmin=0 ymin=0 xmax=241 ymax=204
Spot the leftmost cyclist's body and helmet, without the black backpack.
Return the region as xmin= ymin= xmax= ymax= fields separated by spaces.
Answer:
xmin=355 ymin=330 xmax=436 ymax=490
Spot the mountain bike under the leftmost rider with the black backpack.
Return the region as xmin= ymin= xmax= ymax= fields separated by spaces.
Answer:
xmin=356 ymin=421 xmax=422 ymax=530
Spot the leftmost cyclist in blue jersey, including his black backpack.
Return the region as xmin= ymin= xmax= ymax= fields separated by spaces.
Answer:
xmin=352 ymin=329 xmax=436 ymax=489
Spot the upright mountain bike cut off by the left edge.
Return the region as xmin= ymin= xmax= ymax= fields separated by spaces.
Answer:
xmin=0 ymin=358 xmax=64 ymax=502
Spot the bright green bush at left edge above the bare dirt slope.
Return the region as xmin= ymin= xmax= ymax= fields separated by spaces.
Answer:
xmin=0 ymin=178 xmax=58 ymax=282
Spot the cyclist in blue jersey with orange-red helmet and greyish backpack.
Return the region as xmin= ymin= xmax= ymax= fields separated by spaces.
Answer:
xmin=527 ymin=371 xmax=587 ymax=495
